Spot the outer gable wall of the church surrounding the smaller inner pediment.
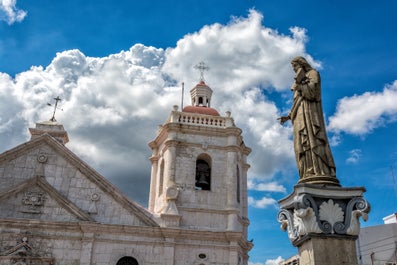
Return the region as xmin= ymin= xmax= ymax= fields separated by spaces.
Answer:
xmin=0 ymin=134 xmax=159 ymax=226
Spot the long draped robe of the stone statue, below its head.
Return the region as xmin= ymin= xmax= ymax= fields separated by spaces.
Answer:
xmin=290 ymin=69 xmax=336 ymax=182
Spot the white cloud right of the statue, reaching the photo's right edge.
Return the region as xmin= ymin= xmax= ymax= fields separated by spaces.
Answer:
xmin=328 ymin=81 xmax=397 ymax=135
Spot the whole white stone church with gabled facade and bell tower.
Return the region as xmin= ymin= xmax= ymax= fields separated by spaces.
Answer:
xmin=0 ymin=72 xmax=253 ymax=265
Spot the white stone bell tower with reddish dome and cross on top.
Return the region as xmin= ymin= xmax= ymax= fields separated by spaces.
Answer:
xmin=149 ymin=64 xmax=251 ymax=237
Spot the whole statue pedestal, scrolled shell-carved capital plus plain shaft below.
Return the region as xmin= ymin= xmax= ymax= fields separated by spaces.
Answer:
xmin=278 ymin=184 xmax=370 ymax=265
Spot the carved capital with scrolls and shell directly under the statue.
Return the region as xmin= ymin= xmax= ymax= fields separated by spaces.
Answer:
xmin=278 ymin=185 xmax=370 ymax=245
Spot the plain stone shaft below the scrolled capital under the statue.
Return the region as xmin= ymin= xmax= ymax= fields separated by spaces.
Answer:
xmin=298 ymin=236 xmax=358 ymax=265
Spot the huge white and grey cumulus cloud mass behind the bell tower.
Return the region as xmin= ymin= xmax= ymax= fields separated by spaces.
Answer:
xmin=0 ymin=10 xmax=311 ymax=203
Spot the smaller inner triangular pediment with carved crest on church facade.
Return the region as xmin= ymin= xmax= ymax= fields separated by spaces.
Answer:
xmin=0 ymin=176 xmax=94 ymax=222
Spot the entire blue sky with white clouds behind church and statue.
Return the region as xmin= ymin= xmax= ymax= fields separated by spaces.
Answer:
xmin=0 ymin=0 xmax=397 ymax=265
